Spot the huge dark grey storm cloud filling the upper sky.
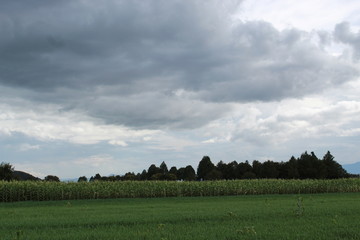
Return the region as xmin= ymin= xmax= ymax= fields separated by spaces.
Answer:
xmin=0 ymin=0 xmax=358 ymax=128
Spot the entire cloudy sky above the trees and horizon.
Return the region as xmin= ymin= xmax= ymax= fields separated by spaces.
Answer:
xmin=0 ymin=0 xmax=360 ymax=179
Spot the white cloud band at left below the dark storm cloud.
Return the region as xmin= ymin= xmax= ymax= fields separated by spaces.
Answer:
xmin=0 ymin=98 xmax=157 ymax=145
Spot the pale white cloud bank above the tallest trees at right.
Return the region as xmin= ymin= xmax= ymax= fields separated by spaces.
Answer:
xmin=202 ymin=81 xmax=360 ymax=147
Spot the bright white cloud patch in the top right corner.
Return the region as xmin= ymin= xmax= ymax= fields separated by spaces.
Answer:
xmin=238 ymin=0 xmax=360 ymax=31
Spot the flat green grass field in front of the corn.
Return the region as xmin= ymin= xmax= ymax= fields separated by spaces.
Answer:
xmin=0 ymin=193 xmax=360 ymax=240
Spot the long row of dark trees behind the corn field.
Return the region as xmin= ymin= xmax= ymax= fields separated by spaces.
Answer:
xmin=78 ymin=151 xmax=350 ymax=181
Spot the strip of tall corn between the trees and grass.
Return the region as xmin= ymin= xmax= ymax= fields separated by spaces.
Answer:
xmin=0 ymin=178 xmax=360 ymax=202
